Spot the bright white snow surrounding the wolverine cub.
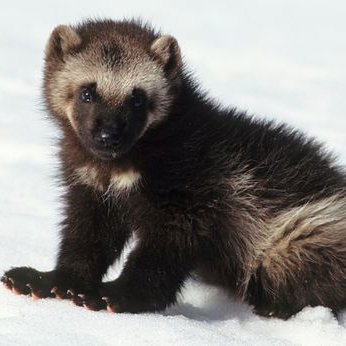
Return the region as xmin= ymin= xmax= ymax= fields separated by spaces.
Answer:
xmin=0 ymin=0 xmax=346 ymax=346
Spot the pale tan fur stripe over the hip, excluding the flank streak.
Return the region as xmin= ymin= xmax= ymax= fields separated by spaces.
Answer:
xmin=254 ymin=194 xmax=346 ymax=285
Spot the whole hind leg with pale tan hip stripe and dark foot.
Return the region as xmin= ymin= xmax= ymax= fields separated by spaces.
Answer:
xmin=247 ymin=195 xmax=346 ymax=319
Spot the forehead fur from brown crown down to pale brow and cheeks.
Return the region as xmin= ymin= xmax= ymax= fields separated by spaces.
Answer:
xmin=47 ymin=21 xmax=170 ymax=121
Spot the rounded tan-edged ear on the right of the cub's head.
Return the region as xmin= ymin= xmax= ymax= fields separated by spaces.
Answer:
xmin=150 ymin=35 xmax=182 ymax=78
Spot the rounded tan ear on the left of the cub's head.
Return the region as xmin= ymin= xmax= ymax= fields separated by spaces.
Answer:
xmin=46 ymin=25 xmax=82 ymax=61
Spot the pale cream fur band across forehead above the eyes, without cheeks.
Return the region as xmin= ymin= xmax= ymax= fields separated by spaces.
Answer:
xmin=59 ymin=47 xmax=167 ymax=106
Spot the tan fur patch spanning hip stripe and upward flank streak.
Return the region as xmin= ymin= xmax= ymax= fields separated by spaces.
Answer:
xmin=228 ymin=170 xmax=346 ymax=298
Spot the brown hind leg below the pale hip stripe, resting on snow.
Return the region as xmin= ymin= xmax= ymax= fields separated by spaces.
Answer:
xmin=247 ymin=219 xmax=346 ymax=319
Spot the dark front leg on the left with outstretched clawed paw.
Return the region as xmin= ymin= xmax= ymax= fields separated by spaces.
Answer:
xmin=1 ymin=185 xmax=129 ymax=298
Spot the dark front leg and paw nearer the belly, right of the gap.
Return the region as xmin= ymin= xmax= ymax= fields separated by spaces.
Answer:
xmin=84 ymin=231 xmax=193 ymax=313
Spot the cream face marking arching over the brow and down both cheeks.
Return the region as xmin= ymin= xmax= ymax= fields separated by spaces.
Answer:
xmin=49 ymin=50 xmax=172 ymax=132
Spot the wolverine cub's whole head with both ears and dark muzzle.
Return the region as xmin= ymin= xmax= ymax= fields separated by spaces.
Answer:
xmin=44 ymin=21 xmax=182 ymax=159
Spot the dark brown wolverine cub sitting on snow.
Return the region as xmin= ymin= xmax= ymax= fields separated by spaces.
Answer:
xmin=2 ymin=20 xmax=346 ymax=318
